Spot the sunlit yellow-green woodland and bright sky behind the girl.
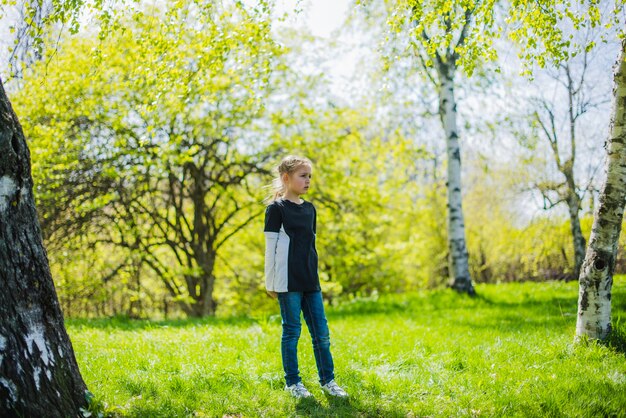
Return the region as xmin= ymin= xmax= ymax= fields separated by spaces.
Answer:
xmin=2 ymin=2 xmax=626 ymax=318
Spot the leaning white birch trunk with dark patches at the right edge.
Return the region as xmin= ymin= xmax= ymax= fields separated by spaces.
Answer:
xmin=576 ymin=41 xmax=626 ymax=340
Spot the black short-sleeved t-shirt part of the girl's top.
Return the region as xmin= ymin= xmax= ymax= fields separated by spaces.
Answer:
xmin=265 ymin=199 xmax=320 ymax=292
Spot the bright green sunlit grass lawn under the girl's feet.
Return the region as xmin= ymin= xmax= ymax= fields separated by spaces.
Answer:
xmin=67 ymin=277 xmax=626 ymax=417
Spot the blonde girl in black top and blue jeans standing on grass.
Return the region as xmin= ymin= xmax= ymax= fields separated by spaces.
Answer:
xmin=265 ymin=155 xmax=348 ymax=398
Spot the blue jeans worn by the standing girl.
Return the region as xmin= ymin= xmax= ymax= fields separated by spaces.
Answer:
xmin=278 ymin=292 xmax=335 ymax=386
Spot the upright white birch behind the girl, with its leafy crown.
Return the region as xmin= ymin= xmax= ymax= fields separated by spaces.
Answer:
xmin=382 ymin=0 xmax=494 ymax=295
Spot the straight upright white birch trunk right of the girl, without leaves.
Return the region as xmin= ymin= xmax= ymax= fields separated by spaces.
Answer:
xmin=439 ymin=70 xmax=475 ymax=295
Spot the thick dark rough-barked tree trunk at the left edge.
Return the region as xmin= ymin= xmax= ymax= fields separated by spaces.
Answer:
xmin=0 ymin=80 xmax=87 ymax=417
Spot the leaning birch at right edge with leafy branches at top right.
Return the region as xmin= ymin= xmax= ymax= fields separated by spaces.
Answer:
xmin=502 ymin=0 xmax=626 ymax=340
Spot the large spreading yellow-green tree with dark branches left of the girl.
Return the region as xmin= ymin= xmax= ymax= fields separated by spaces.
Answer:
xmin=16 ymin=3 xmax=280 ymax=315
